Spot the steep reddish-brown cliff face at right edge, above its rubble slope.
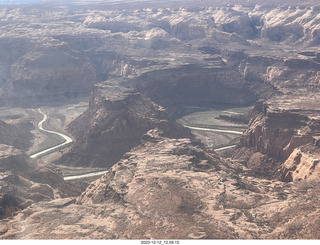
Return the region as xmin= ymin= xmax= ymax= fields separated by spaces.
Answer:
xmin=241 ymin=98 xmax=320 ymax=181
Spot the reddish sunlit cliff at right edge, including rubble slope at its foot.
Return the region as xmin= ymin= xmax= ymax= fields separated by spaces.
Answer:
xmin=233 ymin=96 xmax=320 ymax=181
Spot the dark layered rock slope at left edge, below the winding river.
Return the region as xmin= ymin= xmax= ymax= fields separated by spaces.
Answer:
xmin=0 ymin=145 xmax=79 ymax=219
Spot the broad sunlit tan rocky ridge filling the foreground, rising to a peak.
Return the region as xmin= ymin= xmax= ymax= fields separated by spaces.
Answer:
xmin=0 ymin=129 xmax=320 ymax=239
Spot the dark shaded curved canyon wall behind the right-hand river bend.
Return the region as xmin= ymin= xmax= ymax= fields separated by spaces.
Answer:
xmin=135 ymin=65 xmax=256 ymax=111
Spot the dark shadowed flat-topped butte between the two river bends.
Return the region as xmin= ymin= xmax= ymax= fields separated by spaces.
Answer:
xmin=59 ymin=84 xmax=192 ymax=167
